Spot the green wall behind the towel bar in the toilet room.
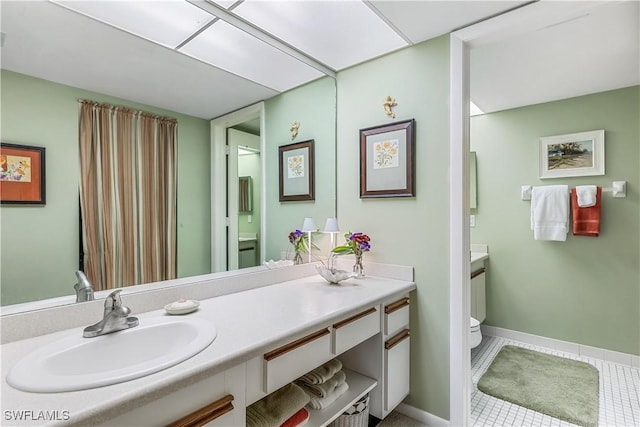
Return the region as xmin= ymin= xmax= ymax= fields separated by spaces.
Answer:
xmin=471 ymin=86 xmax=640 ymax=355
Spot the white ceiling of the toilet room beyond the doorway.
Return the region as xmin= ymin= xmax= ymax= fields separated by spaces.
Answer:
xmin=470 ymin=1 xmax=640 ymax=112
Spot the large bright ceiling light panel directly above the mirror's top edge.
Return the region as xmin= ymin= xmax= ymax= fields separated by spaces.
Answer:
xmin=234 ymin=0 xmax=407 ymax=70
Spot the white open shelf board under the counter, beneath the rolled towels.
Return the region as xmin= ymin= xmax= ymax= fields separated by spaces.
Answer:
xmin=307 ymin=368 xmax=378 ymax=426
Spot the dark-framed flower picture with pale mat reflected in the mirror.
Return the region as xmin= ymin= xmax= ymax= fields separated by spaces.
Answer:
xmin=278 ymin=139 xmax=315 ymax=202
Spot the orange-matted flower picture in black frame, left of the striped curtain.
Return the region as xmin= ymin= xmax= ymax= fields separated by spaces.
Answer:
xmin=0 ymin=142 xmax=46 ymax=205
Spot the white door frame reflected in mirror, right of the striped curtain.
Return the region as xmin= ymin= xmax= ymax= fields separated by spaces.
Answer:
xmin=211 ymin=102 xmax=267 ymax=273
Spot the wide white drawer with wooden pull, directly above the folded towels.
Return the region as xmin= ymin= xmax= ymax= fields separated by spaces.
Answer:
xmin=264 ymin=329 xmax=333 ymax=393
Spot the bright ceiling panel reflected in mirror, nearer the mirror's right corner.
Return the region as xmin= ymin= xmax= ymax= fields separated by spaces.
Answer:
xmin=180 ymin=21 xmax=323 ymax=91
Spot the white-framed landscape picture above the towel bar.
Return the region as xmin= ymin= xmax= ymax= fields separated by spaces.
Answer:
xmin=539 ymin=129 xmax=604 ymax=179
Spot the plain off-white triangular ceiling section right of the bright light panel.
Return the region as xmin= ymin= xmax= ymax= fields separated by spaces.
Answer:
xmin=369 ymin=0 xmax=528 ymax=43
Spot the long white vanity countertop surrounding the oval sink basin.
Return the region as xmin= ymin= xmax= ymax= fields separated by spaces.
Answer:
xmin=0 ymin=275 xmax=415 ymax=426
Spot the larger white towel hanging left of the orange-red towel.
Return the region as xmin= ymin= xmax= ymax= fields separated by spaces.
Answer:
xmin=531 ymin=185 xmax=569 ymax=242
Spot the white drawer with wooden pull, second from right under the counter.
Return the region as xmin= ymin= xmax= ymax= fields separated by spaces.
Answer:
xmin=332 ymin=307 xmax=380 ymax=354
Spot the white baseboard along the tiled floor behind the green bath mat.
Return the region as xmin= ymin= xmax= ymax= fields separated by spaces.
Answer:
xmin=481 ymin=325 xmax=640 ymax=368
